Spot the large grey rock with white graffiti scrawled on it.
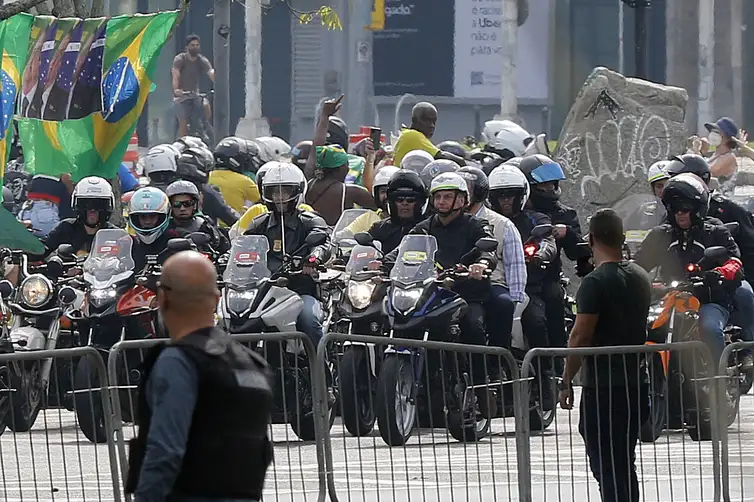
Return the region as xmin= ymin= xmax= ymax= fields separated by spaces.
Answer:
xmin=554 ymin=67 xmax=688 ymax=223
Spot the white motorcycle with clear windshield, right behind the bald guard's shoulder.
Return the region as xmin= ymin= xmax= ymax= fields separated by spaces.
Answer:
xmin=217 ymin=234 xmax=335 ymax=441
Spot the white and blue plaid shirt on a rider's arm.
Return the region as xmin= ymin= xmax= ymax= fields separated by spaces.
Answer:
xmin=475 ymin=206 xmax=527 ymax=303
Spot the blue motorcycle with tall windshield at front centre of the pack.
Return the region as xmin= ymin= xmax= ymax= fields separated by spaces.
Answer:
xmin=376 ymin=235 xmax=497 ymax=446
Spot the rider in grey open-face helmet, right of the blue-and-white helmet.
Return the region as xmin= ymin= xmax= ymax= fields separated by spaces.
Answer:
xmin=165 ymin=180 xmax=230 ymax=254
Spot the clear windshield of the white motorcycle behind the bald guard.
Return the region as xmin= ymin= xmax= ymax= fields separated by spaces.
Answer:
xmin=223 ymin=235 xmax=272 ymax=287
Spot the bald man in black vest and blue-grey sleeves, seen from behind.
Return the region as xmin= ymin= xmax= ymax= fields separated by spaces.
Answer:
xmin=126 ymin=251 xmax=273 ymax=502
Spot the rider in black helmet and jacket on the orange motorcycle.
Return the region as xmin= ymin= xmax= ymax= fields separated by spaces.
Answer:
xmin=635 ymin=173 xmax=743 ymax=361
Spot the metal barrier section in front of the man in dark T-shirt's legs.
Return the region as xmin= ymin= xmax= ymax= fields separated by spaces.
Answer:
xmin=519 ymin=341 xmax=721 ymax=502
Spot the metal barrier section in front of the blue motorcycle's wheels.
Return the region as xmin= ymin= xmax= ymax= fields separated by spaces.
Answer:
xmin=317 ymin=333 xmax=525 ymax=501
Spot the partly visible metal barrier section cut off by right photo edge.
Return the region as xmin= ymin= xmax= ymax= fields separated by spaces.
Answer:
xmin=717 ymin=342 xmax=754 ymax=502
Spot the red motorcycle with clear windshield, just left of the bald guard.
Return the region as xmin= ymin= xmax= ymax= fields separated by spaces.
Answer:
xmin=74 ymin=229 xmax=167 ymax=443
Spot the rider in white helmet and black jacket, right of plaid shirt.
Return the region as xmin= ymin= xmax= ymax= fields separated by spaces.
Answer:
xmin=488 ymin=164 xmax=558 ymax=409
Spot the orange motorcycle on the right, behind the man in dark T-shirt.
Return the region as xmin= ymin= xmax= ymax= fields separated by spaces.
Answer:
xmin=640 ymin=246 xmax=740 ymax=442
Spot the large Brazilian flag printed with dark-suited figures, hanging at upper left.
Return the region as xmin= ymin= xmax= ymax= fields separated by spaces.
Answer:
xmin=15 ymin=11 xmax=180 ymax=180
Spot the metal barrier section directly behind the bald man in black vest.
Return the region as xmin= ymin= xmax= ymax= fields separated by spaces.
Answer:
xmin=108 ymin=332 xmax=327 ymax=502
